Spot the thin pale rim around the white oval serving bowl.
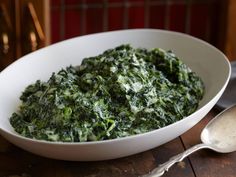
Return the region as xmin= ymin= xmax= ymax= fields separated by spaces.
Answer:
xmin=0 ymin=28 xmax=231 ymax=146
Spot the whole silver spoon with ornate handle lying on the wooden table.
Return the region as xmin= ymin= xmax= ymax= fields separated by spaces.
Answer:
xmin=142 ymin=105 xmax=236 ymax=177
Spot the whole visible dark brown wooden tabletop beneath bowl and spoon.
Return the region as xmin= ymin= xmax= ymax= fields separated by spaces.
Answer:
xmin=0 ymin=109 xmax=236 ymax=177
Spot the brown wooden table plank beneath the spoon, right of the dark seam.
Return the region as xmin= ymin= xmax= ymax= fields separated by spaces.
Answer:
xmin=182 ymin=111 xmax=236 ymax=177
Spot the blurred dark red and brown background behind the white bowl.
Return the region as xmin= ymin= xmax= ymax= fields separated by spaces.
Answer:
xmin=0 ymin=0 xmax=236 ymax=71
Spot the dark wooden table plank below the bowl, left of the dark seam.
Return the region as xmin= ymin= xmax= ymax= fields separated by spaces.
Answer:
xmin=0 ymin=124 xmax=194 ymax=177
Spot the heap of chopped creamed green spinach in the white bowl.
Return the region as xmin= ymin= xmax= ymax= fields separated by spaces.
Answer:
xmin=10 ymin=45 xmax=204 ymax=142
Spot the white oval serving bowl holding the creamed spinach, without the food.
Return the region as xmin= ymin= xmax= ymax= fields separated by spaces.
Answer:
xmin=0 ymin=29 xmax=231 ymax=161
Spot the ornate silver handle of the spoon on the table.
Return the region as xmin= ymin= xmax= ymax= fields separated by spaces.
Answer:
xmin=142 ymin=143 xmax=209 ymax=177
